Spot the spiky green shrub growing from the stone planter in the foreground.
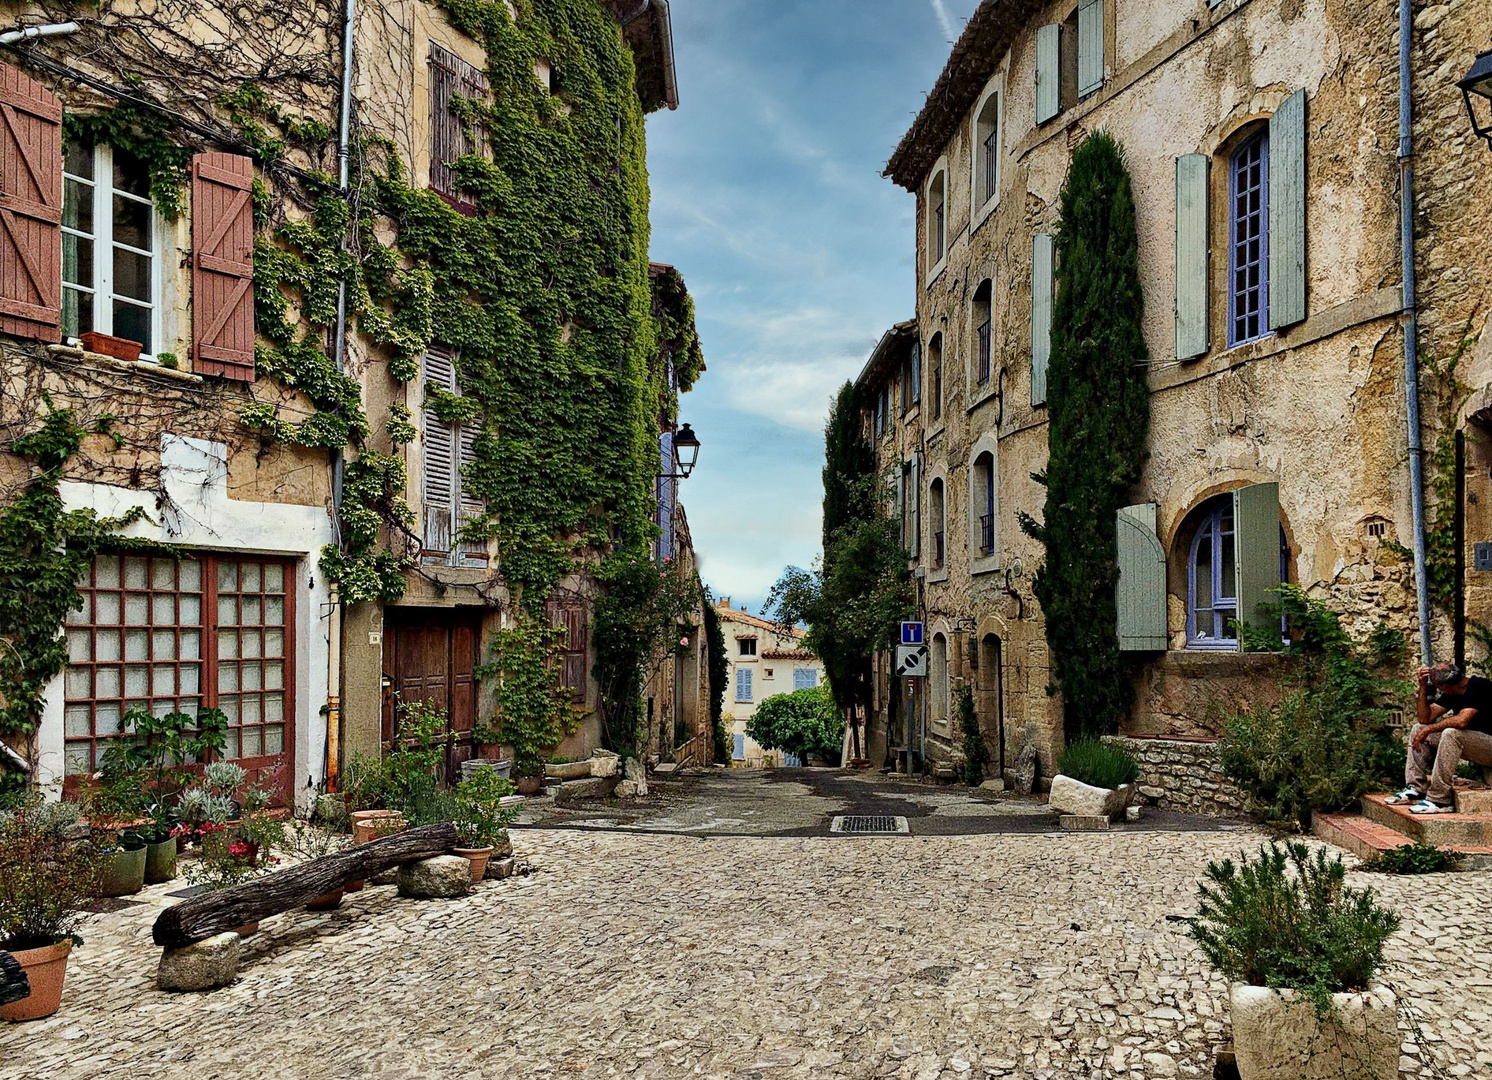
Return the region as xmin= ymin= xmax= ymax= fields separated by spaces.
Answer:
xmin=1191 ymin=841 xmax=1399 ymax=1016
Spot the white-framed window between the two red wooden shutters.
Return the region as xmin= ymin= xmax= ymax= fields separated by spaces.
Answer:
xmin=63 ymin=139 xmax=161 ymax=355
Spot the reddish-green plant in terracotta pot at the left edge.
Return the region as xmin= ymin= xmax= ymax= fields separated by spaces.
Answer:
xmin=0 ymin=800 xmax=98 ymax=1020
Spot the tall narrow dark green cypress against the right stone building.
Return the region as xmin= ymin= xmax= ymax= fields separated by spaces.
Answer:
xmin=1021 ymin=131 xmax=1150 ymax=741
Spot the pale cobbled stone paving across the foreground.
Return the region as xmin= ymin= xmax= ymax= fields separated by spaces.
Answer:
xmin=0 ymin=829 xmax=1492 ymax=1080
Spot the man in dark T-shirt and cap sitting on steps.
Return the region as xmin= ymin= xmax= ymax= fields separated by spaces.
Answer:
xmin=1389 ymin=664 xmax=1492 ymax=814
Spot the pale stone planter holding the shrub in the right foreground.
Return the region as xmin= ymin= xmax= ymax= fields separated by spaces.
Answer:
xmin=1228 ymin=983 xmax=1399 ymax=1080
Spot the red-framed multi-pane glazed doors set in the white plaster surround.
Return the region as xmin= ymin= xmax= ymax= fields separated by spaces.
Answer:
xmin=63 ymin=555 xmax=294 ymax=776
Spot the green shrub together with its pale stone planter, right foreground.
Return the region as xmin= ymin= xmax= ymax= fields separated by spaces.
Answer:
xmin=1191 ymin=841 xmax=1399 ymax=1080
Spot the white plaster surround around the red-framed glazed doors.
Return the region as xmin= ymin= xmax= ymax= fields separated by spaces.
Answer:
xmin=36 ymin=434 xmax=334 ymax=803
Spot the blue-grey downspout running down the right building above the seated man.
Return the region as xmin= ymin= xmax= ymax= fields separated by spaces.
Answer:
xmin=1399 ymin=0 xmax=1432 ymax=664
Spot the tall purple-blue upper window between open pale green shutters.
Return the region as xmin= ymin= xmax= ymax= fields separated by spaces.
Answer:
xmin=1228 ymin=131 xmax=1270 ymax=345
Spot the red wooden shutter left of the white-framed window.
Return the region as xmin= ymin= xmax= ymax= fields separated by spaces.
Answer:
xmin=0 ymin=64 xmax=63 ymax=342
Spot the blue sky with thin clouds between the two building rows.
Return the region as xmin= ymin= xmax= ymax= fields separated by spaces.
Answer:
xmin=648 ymin=0 xmax=977 ymax=612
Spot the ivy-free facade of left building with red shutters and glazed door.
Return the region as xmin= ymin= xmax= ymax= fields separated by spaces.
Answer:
xmin=0 ymin=0 xmax=709 ymax=801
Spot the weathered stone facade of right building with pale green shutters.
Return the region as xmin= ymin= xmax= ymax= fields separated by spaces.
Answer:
xmin=859 ymin=0 xmax=1492 ymax=793
